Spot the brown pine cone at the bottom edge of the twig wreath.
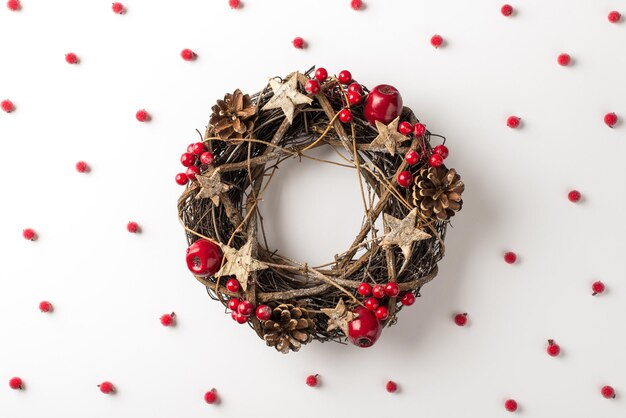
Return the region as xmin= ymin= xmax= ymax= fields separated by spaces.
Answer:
xmin=262 ymin=304 xmax=314 ymax=354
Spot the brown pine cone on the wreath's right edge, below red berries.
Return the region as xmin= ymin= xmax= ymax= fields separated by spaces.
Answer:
xmin=413 ymin=167 xmax=465 ymax=221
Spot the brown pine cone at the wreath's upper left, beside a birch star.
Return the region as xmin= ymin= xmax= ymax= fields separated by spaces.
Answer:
xmin=209 ymin=89 xmax=257 ymax=139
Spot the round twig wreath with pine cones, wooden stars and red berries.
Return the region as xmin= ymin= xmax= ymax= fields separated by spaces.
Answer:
xmin=177 ymin=68 xmax=464 ymax=353
